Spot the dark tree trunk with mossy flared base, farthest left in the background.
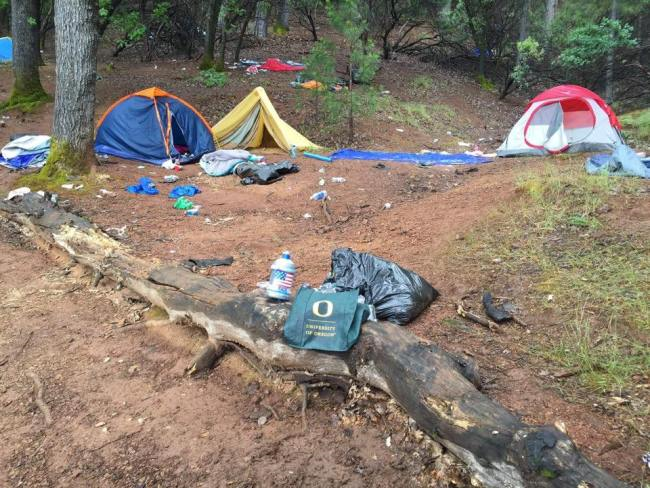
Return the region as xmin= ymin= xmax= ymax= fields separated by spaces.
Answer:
xmin=5 ymin=0 xmax=48 ymax=108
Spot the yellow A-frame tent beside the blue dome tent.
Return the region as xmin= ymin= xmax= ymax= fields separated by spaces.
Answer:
xmin=212 ymin=86 xmax=318 ymax=151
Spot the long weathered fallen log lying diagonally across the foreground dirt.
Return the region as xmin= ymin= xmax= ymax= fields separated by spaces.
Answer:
xmin=0 ymin=193 xmax=625 ymax=488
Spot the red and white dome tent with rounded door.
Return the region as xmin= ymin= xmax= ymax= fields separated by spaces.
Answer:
xmin=497 ymin=85 xmax=623 ymax=157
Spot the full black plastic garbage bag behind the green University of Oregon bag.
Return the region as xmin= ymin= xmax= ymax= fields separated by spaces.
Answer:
xmin=326 ymin=248 xmax=439 ymax=325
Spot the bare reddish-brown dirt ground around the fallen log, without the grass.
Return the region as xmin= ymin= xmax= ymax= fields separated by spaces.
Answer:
xmin=0 ymin=32 xmax=649 ymax=487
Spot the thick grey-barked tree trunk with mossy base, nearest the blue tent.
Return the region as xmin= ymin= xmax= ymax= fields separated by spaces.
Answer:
xmin=46 ymin=0 xmax=98 ymax=175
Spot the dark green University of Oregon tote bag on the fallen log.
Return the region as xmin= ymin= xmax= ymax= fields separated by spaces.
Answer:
xmin=284 ymin=288 xmax=370 ymax=351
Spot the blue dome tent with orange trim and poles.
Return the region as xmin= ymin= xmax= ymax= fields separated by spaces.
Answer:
xmin=95 ymin=87 xmax=215 ymax=165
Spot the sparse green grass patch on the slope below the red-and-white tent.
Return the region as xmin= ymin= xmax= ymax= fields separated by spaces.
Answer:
xmin=458 ymin=163 xmax=650 ymax=392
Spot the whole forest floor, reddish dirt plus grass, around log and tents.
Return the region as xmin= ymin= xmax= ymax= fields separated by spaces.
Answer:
xmin=0 ymin=28 xmax=650 ymax=487
